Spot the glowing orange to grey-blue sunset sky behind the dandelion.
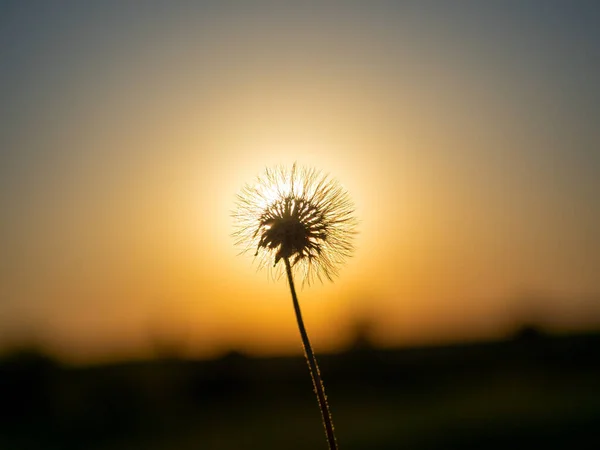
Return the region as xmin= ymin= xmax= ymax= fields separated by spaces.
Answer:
xmin=0 ymin=0 xmax=600 ymax=362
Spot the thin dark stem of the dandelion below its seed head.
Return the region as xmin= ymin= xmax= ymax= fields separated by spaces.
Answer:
xmin=284 ymin=258 xmax=338 ymax=450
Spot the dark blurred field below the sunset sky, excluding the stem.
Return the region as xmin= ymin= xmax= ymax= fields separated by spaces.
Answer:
xmin=0 ymin=329 xmax=600 ymax=450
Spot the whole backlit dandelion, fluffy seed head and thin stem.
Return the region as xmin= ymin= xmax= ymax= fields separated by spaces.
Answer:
xmin=233 ymin=163 xmax=357 ymax=450
